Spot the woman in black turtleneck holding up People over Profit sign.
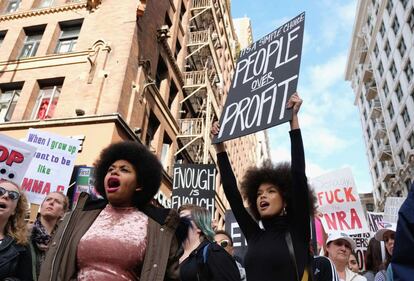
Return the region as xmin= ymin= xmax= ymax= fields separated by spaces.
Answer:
xmin=212 ymin=93 xmax=311 ymax=281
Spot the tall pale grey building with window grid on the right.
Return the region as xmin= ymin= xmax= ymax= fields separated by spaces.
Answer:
xmin=346 ymin=0 xmax=414 ymax=210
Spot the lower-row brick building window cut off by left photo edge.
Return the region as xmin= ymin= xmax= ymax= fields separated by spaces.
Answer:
xmin=0 ymin=82 xmax=23 ymax=123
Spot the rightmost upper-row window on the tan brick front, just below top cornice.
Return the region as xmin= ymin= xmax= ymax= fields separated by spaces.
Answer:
xmin=55 ymin=21 xmax=82 ymax=54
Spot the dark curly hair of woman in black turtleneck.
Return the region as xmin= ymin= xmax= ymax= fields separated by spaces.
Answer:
xmin=241 ymin=160 xmax=292 ymax=220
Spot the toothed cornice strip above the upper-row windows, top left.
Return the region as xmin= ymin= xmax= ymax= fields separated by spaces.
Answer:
xmin=0 ymin=0 xmax=88 ymax=22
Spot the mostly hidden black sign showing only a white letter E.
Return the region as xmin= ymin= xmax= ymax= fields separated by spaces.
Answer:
xmin=224 ymin=210 xmax=247 ymax=263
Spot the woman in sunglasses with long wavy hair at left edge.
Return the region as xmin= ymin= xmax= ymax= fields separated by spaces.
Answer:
xmin=0 ymin=179 xmax=32 ymax=281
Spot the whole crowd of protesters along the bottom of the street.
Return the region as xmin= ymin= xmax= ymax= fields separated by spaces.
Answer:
xmin=0 ymin=94 xmax=414 ymax=281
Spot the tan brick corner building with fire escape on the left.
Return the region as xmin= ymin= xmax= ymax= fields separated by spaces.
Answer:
xmin=0 ymin=0 xmax=262 ymax=223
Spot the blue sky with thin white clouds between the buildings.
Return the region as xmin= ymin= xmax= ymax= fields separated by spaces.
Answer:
xmin=231 ymin=0 xmax=372 ymax=193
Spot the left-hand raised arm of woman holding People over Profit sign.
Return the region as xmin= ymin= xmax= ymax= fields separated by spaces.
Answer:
xmin=211 ymin=122 xmax=260 ymax=240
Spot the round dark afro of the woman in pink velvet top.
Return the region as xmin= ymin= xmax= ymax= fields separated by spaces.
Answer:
xmin=94 ymin=141 xmax=162 ymax=208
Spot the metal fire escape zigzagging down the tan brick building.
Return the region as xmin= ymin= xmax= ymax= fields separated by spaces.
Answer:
xmin=176 ymin=0 xmax=222 ymax=164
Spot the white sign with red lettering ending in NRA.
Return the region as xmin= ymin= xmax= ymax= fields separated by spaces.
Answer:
xmin=311 ymin=168 xmax=369 ymax=234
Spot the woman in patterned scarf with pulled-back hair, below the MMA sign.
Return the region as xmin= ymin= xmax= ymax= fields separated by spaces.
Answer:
xmin=30 ymin=192 xmax=69 ymax=280
